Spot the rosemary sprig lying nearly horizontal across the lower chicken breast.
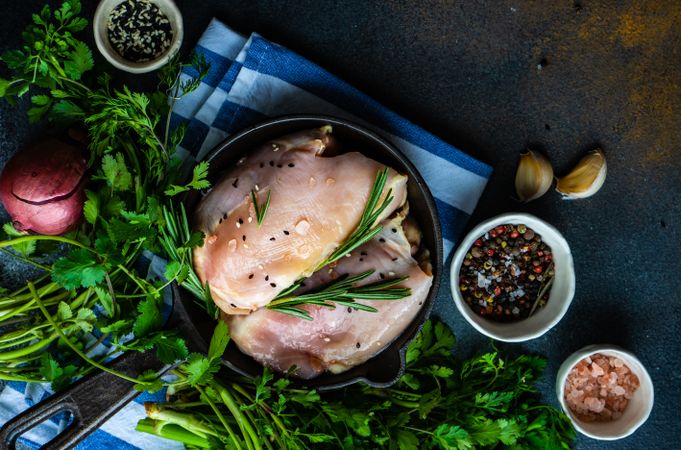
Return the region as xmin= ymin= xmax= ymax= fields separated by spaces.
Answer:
xmin=267 ymin=270 xmax=411 ymax=320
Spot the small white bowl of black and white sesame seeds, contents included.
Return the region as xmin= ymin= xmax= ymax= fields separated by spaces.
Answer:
xmin=93 ymin=0 xmax=184 ymax=73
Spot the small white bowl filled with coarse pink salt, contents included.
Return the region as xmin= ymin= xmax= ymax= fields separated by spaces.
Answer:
xmin=556 ymin=345 xmax=654 ymax=440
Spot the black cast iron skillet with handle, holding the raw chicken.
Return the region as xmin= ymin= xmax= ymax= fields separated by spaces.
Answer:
xmin=0 ymin=115 xmax=443 ymax=449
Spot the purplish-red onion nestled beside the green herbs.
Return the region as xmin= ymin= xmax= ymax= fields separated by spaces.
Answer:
xmin=0 ymin=138 xmax=87 ymax=235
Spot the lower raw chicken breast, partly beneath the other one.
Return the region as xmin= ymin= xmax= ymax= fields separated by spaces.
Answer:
xmin=225 ymin=213 xmax=432 ymax=379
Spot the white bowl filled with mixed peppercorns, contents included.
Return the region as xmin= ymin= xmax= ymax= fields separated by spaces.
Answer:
xmin=451 ymin=213 xmax=575 ymax=342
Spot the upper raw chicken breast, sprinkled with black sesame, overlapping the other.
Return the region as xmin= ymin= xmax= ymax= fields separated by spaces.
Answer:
xmin=194 ymin=127 xmax=407 ymax=314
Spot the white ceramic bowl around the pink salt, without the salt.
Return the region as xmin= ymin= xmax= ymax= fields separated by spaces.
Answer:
xmin=556 ymin=345 xmax=655 ymax=441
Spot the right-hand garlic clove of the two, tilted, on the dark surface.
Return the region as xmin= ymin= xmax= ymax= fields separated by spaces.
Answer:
xmin=556 ymin=148 xmax=608 ymax=200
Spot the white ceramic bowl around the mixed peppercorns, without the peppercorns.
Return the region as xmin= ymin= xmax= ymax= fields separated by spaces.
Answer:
xmin=450 ymin=213 xmax=575 ymax=342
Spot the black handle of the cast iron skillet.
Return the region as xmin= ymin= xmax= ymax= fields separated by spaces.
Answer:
xmin=0 ymin=352 xmax=169 ymax=450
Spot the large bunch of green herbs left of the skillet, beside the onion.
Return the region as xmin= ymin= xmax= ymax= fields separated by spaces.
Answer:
xmin=0 ymin=0 xmax=212 ymax=389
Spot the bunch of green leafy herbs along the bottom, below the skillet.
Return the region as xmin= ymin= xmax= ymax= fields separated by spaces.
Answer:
xmin=137 ymin=322 xmax=575 ymax=450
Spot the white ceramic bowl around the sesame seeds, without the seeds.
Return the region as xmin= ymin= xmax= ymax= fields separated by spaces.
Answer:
xmin=92 ymin=0 xmax=184 ymax=73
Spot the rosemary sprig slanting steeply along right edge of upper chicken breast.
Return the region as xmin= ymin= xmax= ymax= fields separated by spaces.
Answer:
xmin=315 ymin=168 xmax=394 ymax=272
